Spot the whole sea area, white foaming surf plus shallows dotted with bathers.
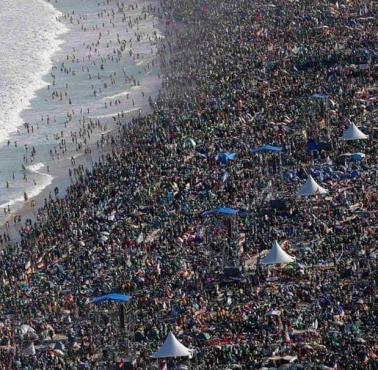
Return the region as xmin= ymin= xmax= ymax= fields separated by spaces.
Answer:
xmin=0 ymin=0 xmax=161 ymax=224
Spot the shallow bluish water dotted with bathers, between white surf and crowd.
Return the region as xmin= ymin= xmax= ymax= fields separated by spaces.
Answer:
xmin=0 ymin=0 xmax=161 ymax=236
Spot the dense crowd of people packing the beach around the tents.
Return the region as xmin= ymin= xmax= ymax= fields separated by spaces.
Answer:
xmin=0 ymin=0 xmax=378 ymax=370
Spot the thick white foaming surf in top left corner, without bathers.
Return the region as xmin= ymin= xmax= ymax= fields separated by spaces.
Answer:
xmin=0 ymin=0 xmax=68 ymax=145
